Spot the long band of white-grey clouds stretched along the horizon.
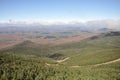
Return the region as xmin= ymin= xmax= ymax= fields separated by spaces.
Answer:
xmin=0 ymin=19 xmax=120 ymax=29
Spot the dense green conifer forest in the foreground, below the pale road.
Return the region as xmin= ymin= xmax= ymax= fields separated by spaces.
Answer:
xmin=0 ymin=54 xmax=120 ymax=80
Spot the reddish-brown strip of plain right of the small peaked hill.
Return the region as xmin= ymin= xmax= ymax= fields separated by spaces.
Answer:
xmin=28 ymin=34 xmax=97 ymax=45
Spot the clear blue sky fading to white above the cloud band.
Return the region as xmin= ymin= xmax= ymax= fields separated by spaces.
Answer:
xmin=0 ymin=0 xmax=120 ymax=22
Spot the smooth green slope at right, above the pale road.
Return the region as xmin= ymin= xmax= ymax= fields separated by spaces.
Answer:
xmin=52 ymin=32 xmax=120 ymax=65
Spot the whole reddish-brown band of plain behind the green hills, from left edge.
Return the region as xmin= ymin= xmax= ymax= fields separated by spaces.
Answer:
xmin=0 ymin=34 xmax=96 ymax=49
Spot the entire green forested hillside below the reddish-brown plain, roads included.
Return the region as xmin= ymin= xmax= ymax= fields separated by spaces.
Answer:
xmin=0 ymin=32 xmax=120 ymax=80
